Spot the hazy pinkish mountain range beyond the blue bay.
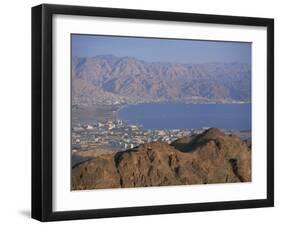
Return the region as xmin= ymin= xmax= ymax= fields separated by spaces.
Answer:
xmin=72 ymin=55 xmax=251 ymax=104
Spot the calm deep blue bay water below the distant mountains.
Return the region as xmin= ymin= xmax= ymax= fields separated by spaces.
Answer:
xmin=118 ymin=103 xmax=251 ymax=130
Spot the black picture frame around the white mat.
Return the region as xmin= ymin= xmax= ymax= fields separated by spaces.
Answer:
xmin=32 ymin=4 xmax=274 ymax=221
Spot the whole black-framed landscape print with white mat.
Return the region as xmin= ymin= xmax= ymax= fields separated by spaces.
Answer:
xmin=32 ymin=4 xmax=274 ymax=221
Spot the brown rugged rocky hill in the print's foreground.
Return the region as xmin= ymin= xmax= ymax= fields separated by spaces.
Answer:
xmin=72 ymin=129 xmax=251 ymax=190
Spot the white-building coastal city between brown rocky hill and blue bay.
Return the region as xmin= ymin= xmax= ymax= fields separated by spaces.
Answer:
xmin=72 ymin=119 xmax=207 ymax=153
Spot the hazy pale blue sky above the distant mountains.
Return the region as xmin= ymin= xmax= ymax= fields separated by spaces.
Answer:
xmin=72 ymin=34 xmax=251 ymax=63
